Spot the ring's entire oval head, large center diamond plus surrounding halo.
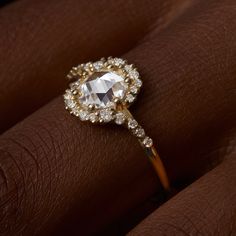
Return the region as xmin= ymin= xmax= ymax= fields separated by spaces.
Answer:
xmin=64 ymin=57 xmax=142 ymax=124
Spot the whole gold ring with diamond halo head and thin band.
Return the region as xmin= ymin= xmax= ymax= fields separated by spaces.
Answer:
xmin=64 ymin=57 xmax=170 ymax=191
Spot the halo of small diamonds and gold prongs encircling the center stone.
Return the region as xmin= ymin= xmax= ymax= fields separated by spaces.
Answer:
xmin=64 ymin=57 xmax=142 ymax=124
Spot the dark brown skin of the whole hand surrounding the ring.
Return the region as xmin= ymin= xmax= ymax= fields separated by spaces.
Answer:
xmin=0 ymin=0 xmax=236 ymax=235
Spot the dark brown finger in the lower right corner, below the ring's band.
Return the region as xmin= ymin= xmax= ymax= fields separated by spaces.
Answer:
xmin=128 ymin=148 xmax=236 ymax=236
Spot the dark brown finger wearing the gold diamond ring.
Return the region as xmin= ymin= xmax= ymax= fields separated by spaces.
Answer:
xmin=0 ymin=2 xmax=236 ymax=235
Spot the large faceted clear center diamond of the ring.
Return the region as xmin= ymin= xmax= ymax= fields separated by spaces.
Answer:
xmin=79 ymin=72 xmax=127 ymax=108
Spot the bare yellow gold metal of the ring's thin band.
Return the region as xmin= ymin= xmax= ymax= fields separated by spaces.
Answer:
xmin=120 ymin=106 xmax=170 ymax=191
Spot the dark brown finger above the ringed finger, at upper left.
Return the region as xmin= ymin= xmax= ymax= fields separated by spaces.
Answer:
xmin=0 ymin=0 xmax=190 ymax=131
